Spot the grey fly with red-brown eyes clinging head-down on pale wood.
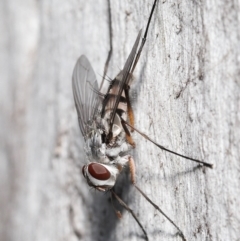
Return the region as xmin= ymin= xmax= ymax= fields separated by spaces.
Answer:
xmin=72 ymin=0 xmax=212 ymax=241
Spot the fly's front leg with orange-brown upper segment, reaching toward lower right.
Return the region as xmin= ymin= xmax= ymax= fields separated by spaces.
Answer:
xmin=128 ymin=156 xmax=187 ymax=241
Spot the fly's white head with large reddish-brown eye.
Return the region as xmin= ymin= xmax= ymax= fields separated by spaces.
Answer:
xmin=82 ymin=162 xmax=121 ymax=192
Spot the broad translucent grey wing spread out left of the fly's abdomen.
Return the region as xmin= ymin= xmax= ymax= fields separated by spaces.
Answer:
xmin=72 ymin=55 xmax=101 ymax=138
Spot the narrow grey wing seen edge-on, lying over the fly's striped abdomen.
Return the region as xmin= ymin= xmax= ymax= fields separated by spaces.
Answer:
xmin=106 ymin=30 xmax=142 ymax=135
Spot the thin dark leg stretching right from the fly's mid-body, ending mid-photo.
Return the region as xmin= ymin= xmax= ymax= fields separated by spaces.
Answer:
xmin=122 ymin=119 xmax=213 ymax=168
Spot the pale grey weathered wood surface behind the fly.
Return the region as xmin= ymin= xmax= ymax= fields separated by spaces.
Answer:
xmin=0 ymin=0 xmax=240 ymax=241
